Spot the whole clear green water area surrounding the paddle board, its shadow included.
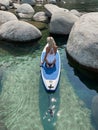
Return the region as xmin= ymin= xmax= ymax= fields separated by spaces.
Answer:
xmin=0 ymin=39 xmax=96 ymax=130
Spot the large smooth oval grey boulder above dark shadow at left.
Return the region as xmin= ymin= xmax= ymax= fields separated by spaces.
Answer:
xmin=0 ymin=20 xmax=42 ymax=42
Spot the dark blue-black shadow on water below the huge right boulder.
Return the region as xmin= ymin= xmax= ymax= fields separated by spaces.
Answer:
xmin=63 ymin=48 xmax=98 ymax=105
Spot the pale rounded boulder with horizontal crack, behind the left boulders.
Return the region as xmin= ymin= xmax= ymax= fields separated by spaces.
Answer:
xmin=16 ymin=4 xmax=35 ymax=18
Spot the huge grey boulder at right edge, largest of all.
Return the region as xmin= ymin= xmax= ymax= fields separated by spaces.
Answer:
xmin=66 ymin=12 xmax=98 ymax=79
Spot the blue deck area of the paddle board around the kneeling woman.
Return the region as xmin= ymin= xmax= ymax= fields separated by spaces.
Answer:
xmin=41 ymin=52 xmax=59 ymax=80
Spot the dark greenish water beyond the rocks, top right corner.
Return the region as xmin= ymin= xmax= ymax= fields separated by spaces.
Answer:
xmin=58 ymin=0 xmax=98 ymax=12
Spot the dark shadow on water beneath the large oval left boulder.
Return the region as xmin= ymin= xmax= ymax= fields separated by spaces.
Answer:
xmin=0 ymin=41 xmax=40 ymax=56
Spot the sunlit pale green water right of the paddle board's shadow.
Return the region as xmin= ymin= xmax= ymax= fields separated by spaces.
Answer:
xmin=56 ymin=50 xmax=94 ymax=130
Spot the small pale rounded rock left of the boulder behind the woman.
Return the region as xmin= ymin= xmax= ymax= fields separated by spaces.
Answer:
xmin=33 ymin=11 xmax=48 ymax=22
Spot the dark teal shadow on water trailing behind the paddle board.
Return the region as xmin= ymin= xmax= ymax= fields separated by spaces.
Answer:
xmin=39 ymin=76 xmax=60 ymax=130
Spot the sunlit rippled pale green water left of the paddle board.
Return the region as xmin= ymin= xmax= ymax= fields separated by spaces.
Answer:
xmin=0 ymin=57 xmax=43 ymax=130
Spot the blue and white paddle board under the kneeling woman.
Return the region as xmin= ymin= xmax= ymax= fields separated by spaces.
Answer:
xmin=41 ymin=44 xmax=61 ymax=91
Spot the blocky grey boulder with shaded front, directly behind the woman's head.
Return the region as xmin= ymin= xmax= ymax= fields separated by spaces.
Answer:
xmin=49 ymin=11 xmax=79 ymax=35
